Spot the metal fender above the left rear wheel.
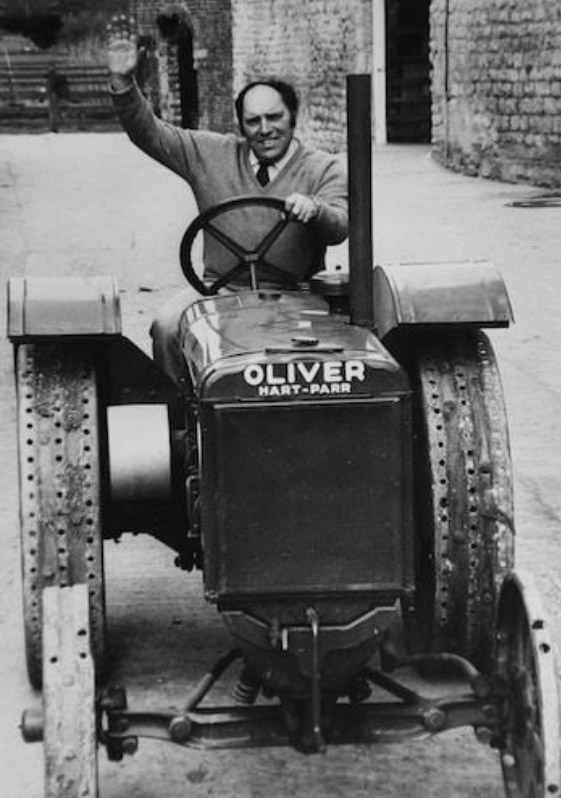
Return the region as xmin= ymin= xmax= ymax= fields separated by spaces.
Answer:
xmin=8 ymin=276 xmax=121 ymax=342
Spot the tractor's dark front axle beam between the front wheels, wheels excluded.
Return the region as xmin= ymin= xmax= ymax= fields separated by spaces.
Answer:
xmin=98 ymin=657 xmax=507 ymax=759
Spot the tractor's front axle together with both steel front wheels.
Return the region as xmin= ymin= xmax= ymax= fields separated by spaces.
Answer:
xmin=21 ymin=573 xmax=560 ymax=798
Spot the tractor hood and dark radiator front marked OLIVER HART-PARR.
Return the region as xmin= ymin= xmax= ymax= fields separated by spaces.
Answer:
xmin=184 ymin=292 xmax=413 ymax=620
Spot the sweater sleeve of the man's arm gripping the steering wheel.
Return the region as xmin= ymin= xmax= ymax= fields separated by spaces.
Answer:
xmin=312 ymin=157 xmax=349 ymax=245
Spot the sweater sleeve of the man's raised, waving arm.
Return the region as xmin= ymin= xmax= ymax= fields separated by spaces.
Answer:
xmin=111 ymin=83 xmax=224 ymax=184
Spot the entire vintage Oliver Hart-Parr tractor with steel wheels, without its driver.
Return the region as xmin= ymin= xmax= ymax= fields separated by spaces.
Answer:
xmin=9 ymin=76 xmax=561 ymax=798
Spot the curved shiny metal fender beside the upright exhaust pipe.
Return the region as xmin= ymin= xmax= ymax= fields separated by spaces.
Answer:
xmin=374 ymin=261 xmax=513 ymax=340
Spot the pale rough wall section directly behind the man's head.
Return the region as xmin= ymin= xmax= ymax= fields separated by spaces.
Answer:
xmin=232 ymin=0 xmax=372 ymax=152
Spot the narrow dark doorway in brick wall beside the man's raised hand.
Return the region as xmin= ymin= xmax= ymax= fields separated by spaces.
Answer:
xmin=156 ymin=12 xmax=199 ymax=128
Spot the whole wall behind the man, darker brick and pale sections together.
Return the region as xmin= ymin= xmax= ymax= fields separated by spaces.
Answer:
xmin=129 ymin=0 xmax=372 ymax=152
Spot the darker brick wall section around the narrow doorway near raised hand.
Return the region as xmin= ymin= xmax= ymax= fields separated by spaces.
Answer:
xmin=129 ymin=0 xmax=234 ymax=131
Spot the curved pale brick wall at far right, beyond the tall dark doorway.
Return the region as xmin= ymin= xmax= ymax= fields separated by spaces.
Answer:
xmin=431 ymin=0 xmax=561 ymax=186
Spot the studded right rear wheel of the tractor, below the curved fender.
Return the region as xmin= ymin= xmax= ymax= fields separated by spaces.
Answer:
xmin=405 ymin=331 xmax=514 ymax=670
